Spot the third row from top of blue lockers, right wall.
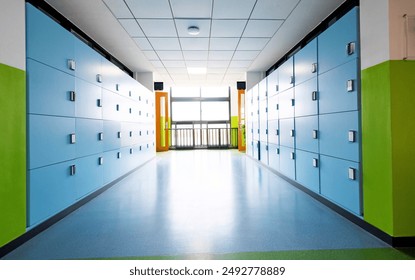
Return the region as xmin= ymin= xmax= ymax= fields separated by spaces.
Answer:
xmin=247 ymin=112 xmax=360 ymax=162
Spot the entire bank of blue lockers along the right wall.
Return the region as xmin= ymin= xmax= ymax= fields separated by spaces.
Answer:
xmin=245 ymin=7 xmax=363 ymax=216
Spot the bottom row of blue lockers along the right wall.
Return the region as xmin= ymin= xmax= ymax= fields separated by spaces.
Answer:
xmin=247 ymin=141 xmax=361 ymax=215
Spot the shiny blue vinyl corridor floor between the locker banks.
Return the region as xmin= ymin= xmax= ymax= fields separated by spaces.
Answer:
xmin=4 ymin=150 xmax=389 ymax=259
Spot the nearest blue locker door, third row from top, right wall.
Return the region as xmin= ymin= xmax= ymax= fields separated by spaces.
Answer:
xmin=319 ymin=111 xmax=360 ymax=162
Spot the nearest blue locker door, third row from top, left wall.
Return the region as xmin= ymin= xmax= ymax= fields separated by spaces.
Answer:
xmin=29 ymin=115 xmax=76 ymax=169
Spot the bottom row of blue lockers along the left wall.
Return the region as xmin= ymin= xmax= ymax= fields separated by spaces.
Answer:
xmin=28 ymin=146 xmax=154 ymax=226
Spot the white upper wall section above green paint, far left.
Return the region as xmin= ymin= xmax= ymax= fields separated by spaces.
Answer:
xmin=0 ymin=0 xmax=26 ymax=70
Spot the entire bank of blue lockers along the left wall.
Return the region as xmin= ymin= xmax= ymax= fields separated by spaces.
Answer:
xmin=26 ymin=4 xmax=155 ymax=226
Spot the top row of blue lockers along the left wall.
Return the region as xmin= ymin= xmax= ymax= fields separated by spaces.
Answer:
xmin=26 ymin=4 xmax=146 ymax=101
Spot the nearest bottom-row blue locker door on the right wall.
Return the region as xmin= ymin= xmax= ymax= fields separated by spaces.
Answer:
xmin=320 ymin=156 xmax=362 ymax=215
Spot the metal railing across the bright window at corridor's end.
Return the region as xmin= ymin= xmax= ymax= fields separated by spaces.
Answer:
xmin=170 ymin=128 xmax=238 ymax=149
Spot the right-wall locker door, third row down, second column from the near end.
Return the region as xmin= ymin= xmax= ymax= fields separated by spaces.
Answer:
xmin=295 ymin=116 xmax=319 ymax=153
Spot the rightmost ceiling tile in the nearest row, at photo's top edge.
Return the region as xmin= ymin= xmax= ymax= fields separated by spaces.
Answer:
xmin=251 ymin=0 xmax=300 ymax=19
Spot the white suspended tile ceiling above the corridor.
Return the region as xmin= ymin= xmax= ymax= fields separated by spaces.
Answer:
xmin=46 ymin=0 xmax=344 ymax=86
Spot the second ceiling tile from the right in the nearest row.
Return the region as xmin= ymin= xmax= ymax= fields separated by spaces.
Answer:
xmin=212 ymin=0 xmax=258 ymax=19
